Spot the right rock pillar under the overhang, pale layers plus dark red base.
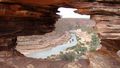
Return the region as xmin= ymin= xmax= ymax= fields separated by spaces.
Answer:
xmin=92 ymin=14 xmax=120 ymax=52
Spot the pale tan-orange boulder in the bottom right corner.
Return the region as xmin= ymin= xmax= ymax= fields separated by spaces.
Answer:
xmin=88 ymin=50 xmax=120 ymax=68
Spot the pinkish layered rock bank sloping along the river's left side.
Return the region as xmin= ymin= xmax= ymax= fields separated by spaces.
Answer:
xmin=16 ymin=32 xmax=70 ymax=55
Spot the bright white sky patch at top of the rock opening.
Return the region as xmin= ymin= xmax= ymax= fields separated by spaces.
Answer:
xmin=57 ymin=7 xmax=90 ymax=19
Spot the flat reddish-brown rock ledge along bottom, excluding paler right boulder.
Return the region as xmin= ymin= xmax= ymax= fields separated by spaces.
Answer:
xmin=0 ymin=57 xmax=89 ymax=68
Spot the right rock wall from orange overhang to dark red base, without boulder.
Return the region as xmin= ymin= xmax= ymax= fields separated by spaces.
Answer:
xmin=73 ymin=0 xmax=120 ymax=51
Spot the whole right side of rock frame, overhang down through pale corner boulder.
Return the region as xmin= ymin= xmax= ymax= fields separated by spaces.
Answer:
xmin=74 ymin=0 xmax=120 ymax=68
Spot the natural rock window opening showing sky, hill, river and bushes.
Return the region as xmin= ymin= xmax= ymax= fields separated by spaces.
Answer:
xmin=16 ymin=7 xmax=100 ymax=61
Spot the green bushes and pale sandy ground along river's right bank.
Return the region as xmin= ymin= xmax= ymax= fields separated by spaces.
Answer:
xmin=48 ymin=26 xmax=100 ymax=61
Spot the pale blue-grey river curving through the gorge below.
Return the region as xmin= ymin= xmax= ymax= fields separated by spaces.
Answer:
xmin=26 ymin=33 xmax=77 ymax=59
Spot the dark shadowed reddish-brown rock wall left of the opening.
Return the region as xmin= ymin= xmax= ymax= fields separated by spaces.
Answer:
xmin=0 ymin=0 xmax=59 ymax=57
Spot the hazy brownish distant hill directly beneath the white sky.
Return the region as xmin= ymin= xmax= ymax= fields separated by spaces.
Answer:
xmin=55 ymin=18 xmax=95 ymax=32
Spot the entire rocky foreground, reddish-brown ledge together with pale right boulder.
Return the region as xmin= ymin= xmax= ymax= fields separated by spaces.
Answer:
xmin=0 ymin=47 xmax=120 ymax=68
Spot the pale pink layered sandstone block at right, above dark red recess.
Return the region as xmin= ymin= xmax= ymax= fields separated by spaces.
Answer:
xmin=92 ymin=15 xmax=120 ymax=39
